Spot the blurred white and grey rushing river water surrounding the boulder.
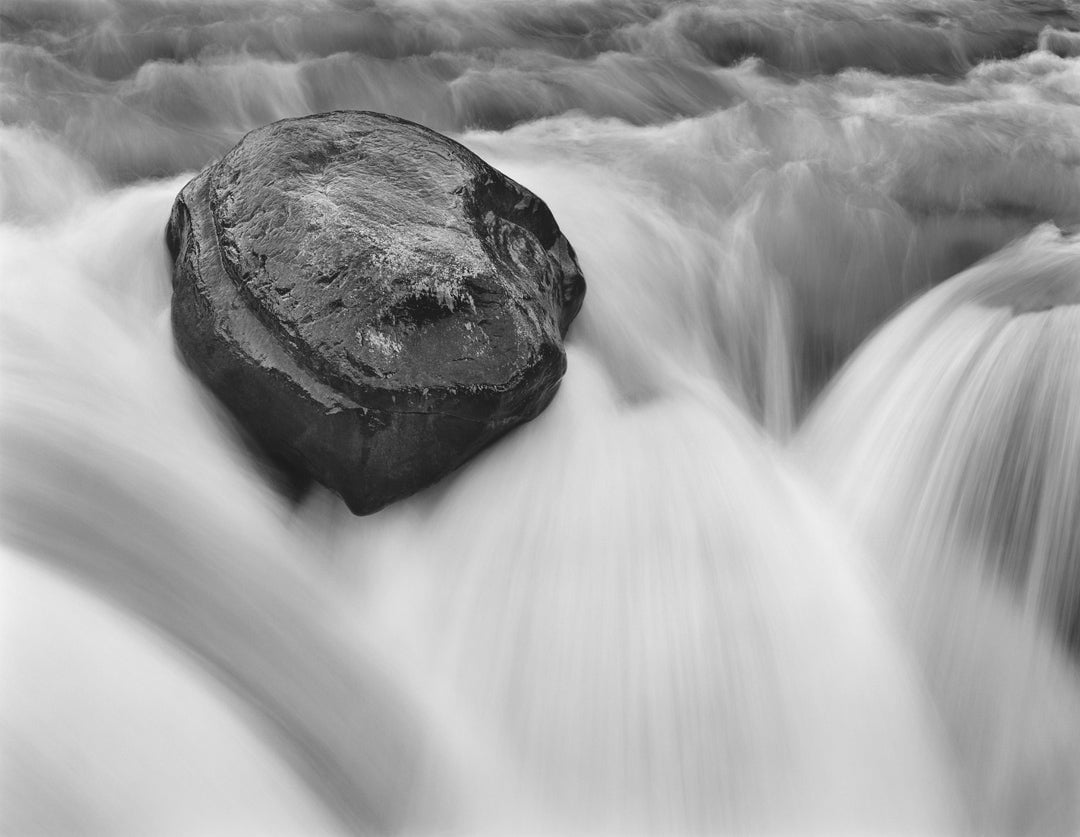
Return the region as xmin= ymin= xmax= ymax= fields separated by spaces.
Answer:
xmin=0 ymin=0 xmax=1080 ymax=835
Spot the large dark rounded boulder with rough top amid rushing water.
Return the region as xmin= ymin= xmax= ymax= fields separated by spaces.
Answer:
xmin=166 ymin=111 xmax=585 ymax=514
